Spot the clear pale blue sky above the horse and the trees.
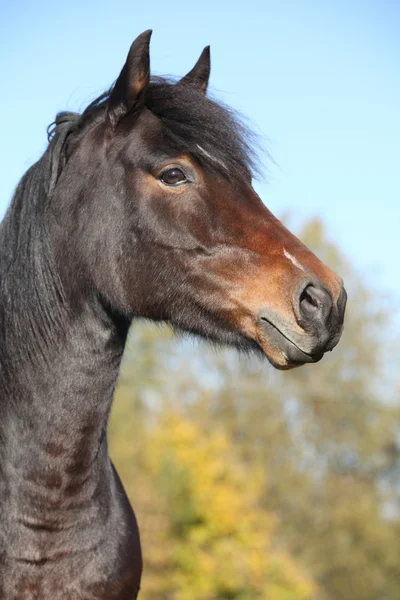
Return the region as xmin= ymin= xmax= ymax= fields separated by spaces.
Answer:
xmin=0 ymin=0 xmax=400 ymax=314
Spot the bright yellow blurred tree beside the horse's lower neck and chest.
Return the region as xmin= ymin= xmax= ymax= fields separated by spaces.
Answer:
xmin=111 ymin=398 xmax=313 ymax=600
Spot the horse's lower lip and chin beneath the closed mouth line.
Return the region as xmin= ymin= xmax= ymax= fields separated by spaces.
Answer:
xmin=259 ymin=316 xmax=324 ymax=369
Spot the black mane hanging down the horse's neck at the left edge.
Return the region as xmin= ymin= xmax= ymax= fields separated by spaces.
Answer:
xmin=0 ymin=114 xmax=77 ymax=364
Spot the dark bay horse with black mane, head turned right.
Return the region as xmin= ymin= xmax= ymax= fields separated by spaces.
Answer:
xmin=0 ymin=31 xmax=346 ymax=600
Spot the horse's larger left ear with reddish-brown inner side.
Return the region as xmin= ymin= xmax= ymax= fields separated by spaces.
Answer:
xmin=107 ymin=29 xmax=152 ymax=127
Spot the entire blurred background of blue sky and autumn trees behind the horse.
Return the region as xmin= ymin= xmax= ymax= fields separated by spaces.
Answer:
xmin=0 ymin=0 xmax=400 ymax=600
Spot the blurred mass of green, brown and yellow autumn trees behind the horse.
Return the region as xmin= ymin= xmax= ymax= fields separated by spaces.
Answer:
xmin=111 ymin=220 xmax=400 ymax=600
